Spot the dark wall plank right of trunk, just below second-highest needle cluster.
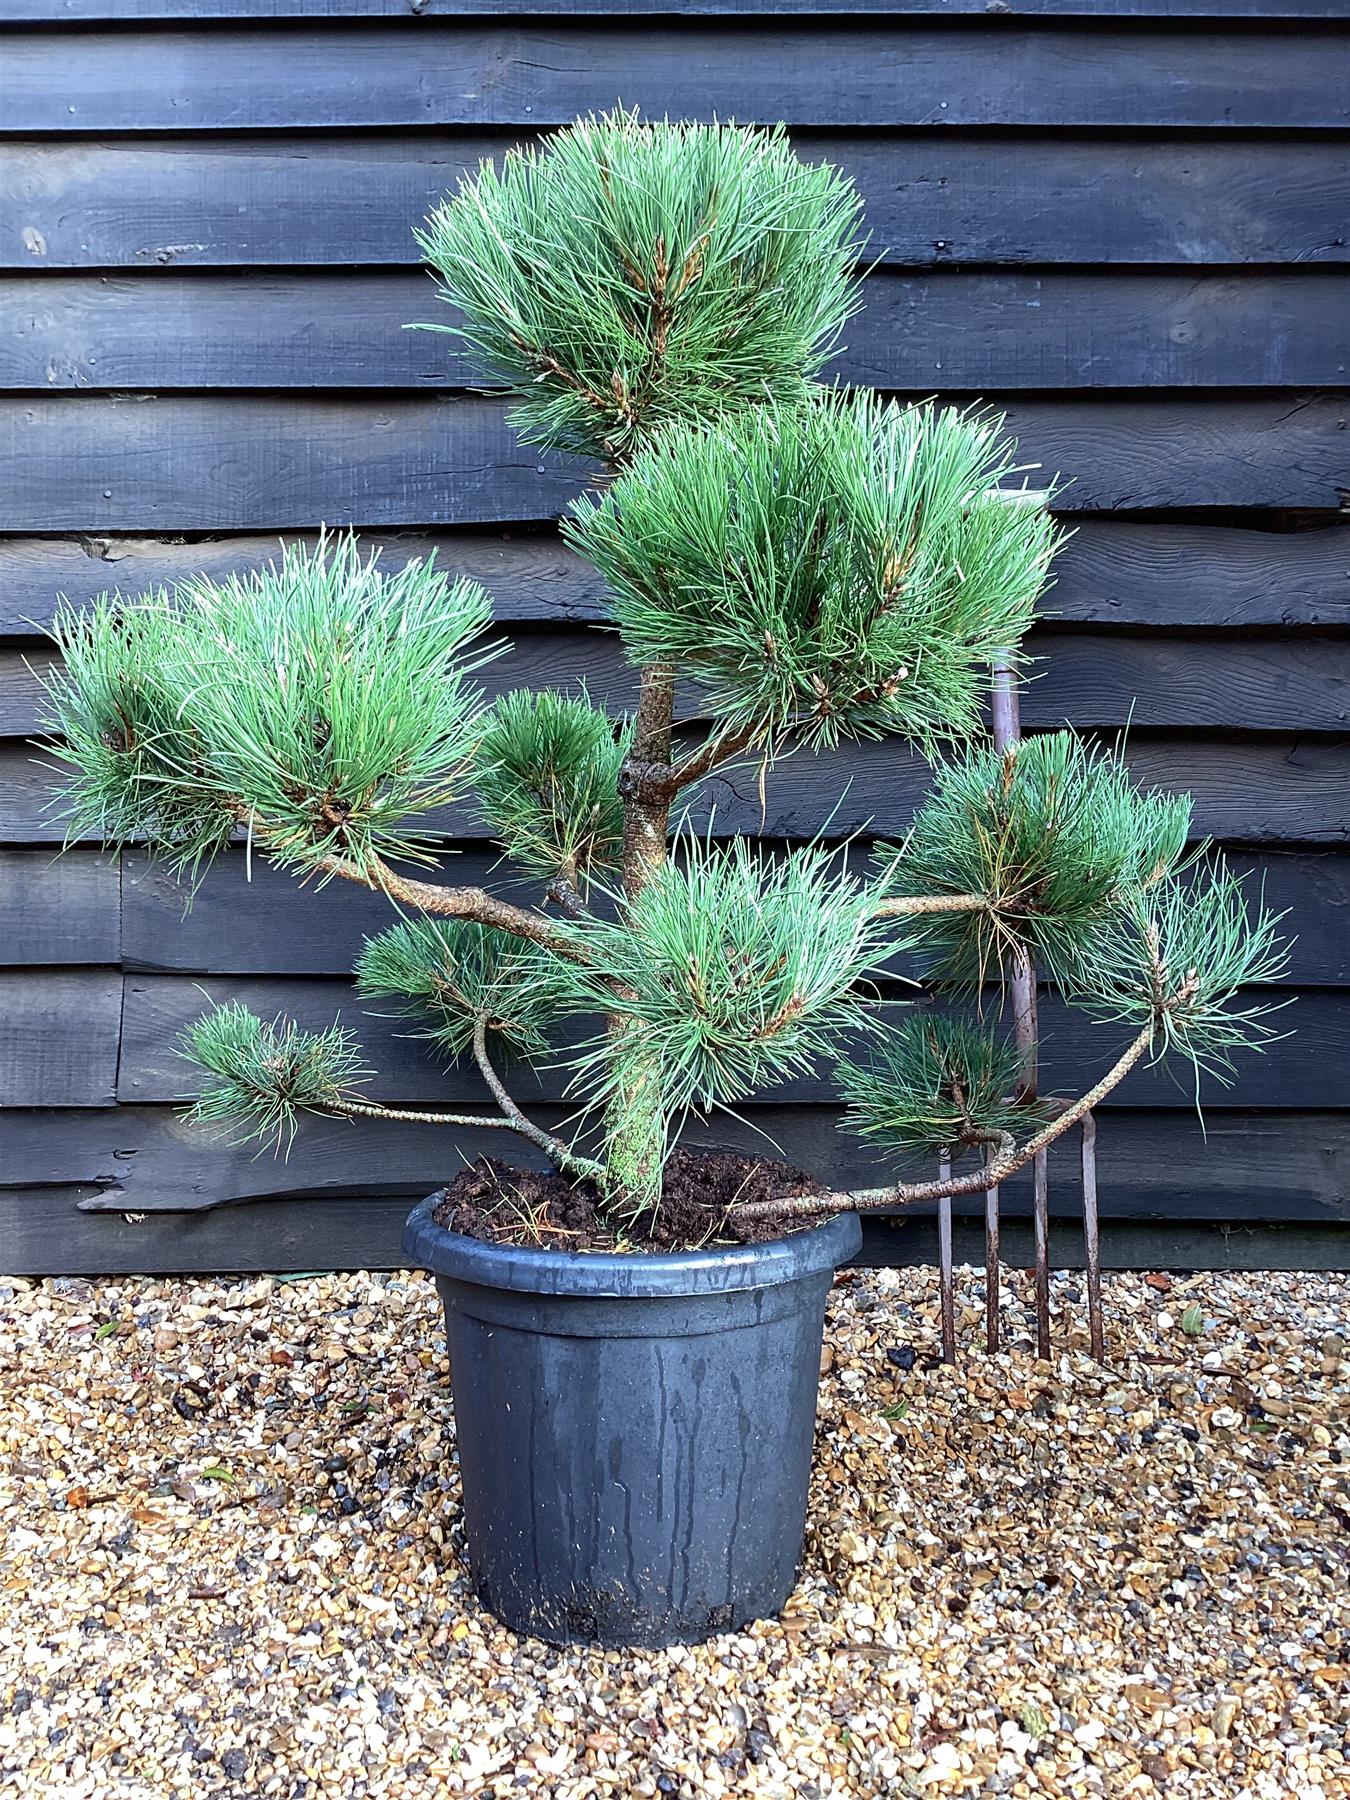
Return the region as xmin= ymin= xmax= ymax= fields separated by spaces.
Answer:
xmin=10 ymin=731 xmax=1350 ymax=846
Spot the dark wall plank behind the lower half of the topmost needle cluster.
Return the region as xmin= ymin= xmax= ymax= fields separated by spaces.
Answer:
xmin=0 ymin=268 xmax=1350 ymax=392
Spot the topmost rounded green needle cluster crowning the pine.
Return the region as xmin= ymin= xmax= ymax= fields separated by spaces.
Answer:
xmin=416 ymin=112 xmax=860 ymax=461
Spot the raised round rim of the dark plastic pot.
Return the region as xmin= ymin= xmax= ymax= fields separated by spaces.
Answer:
xmin=403 ymin=1188 xmax=862 ymax=1300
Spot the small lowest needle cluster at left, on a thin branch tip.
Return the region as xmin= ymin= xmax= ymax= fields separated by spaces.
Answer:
xmin=180 ymin=1001 xmax=371 ymax=1152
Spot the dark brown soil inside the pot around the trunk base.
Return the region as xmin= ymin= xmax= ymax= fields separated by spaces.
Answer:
xmin=432 ymin=1148 xmax=823 ymax=1251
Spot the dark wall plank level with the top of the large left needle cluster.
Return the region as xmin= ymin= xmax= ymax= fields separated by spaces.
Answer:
xmin=0 ymin=515 xmax=1350 ymax=637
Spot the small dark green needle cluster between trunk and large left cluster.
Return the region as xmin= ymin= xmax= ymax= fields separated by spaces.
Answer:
xmin=477 ymin=688 xmax=630 ymax=886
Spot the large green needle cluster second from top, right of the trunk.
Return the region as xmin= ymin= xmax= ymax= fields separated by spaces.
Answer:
xmin=567 ymin=394 xmax=1055 ymax=745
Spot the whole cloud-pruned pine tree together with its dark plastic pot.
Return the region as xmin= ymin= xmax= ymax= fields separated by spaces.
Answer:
xmin=42 ymin=115 xmax=1280 ymax=1643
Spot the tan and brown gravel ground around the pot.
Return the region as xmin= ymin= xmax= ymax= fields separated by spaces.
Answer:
xmin=0 ymin=1271 xmax=1350 ymax=1800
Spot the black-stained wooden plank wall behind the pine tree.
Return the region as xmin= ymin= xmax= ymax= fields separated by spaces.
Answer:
xmin=0 ymin=0 xmax=1350 ymax=1271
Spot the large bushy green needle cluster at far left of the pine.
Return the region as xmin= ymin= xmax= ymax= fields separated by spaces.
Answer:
xmin=49 ymin=535 xmax=504 ymax=873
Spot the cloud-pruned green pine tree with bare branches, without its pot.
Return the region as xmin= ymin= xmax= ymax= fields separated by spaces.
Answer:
xmin=39 ymin=113 xmax=1283 ymax=1229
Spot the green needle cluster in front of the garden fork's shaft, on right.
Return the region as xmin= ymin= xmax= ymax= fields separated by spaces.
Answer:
xmin=886 ymin=731 xmax=1192 ymax=986
